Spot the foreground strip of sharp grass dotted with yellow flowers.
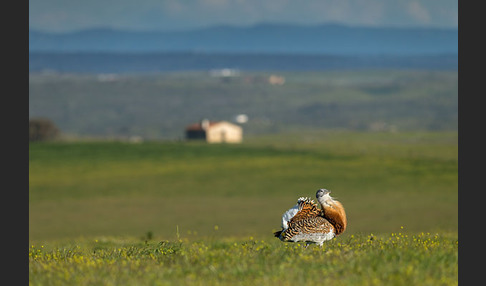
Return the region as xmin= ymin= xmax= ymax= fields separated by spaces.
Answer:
xmin=29 ymin=232 xmax=458 ymax=285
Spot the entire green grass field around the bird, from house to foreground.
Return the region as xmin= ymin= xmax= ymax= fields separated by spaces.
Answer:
xmin=29 ymin=131 xmax=458 ymax=285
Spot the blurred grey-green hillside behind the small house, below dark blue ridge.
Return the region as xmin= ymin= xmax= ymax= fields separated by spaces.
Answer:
xmin=29 ymin=70 xmax=458 ymax=140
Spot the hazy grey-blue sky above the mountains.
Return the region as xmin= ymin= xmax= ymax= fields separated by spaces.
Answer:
xmin=29 ymin=0 xmax=458 ymax=32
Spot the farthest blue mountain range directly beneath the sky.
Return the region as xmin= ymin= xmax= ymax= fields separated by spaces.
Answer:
xmin=29 ymin=24 xmax=458 ymax=56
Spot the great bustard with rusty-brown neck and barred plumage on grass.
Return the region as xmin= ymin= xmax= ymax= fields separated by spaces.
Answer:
xmin=274 ymin=189 xmax=347 ymax=246
